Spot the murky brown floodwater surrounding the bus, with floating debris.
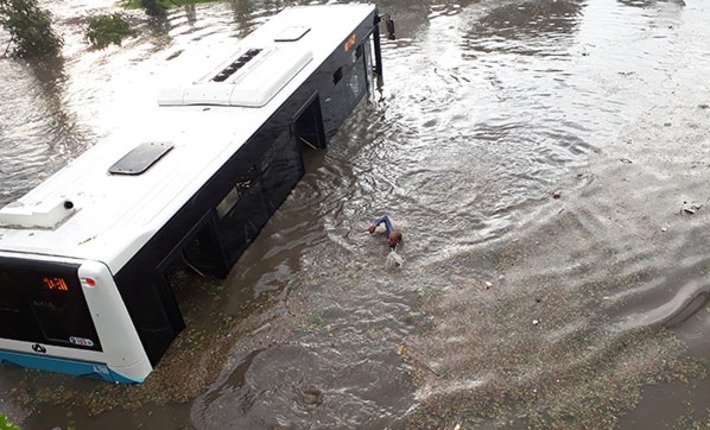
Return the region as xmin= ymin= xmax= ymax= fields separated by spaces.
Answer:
xmin=0 ymin=0 xmax=710 ymax=430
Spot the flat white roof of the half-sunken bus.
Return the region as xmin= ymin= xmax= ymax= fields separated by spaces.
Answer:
xmin=0 ymin=4 xmax=375 ymax=273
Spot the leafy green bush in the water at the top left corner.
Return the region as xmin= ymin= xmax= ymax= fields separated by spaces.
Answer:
xmin=0 ymin=0 xmax=63 ymax=58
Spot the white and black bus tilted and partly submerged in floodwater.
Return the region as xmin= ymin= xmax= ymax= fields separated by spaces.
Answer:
xmin=0 ymin=4 xmax=389 ymax=383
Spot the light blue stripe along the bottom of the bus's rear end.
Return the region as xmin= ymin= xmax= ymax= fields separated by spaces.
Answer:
xmin=0 ymin=351 xmax=145 ymax=384
